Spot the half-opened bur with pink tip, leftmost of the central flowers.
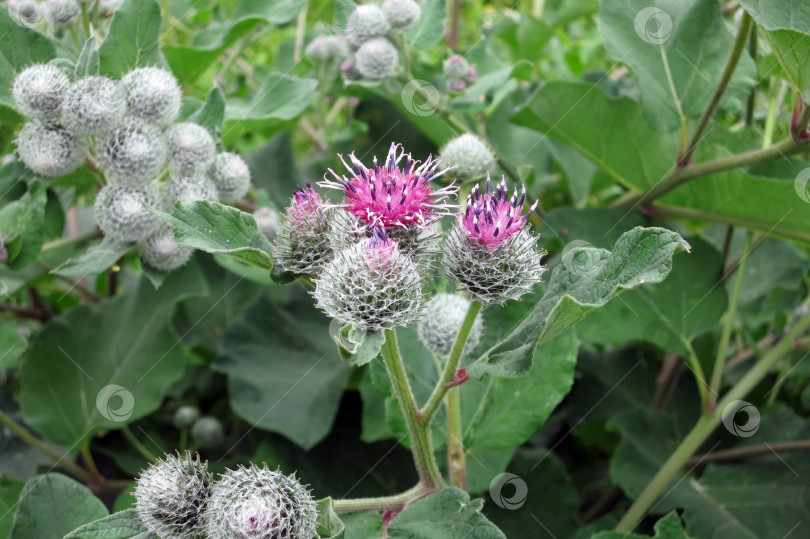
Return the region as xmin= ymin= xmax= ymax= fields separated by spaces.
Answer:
xmin=273 ymin=182 xmax=334 ymax=275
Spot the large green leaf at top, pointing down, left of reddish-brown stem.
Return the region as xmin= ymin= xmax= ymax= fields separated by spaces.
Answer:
xmin=596 ymin=0 xmax=755 ymax=132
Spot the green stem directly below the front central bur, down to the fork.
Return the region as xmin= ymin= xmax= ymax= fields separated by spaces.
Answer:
xmin=382 ymin=329 xmax=445 ymax=493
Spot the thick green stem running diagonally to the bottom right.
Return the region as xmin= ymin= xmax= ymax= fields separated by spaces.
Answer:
xmin=615 ymin=313 xmax=810 ymax=533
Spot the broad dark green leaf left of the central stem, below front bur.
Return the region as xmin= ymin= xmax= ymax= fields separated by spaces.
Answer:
xmin=215 ymin=295 xmax=351 ymax=449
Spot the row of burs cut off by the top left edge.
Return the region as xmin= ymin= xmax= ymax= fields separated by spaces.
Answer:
xmin=6 ymin=0 xmax=124 ymax=28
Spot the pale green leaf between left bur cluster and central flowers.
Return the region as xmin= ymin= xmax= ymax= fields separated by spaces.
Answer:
xmin=145 ymin=200 xmax=273 ymax=270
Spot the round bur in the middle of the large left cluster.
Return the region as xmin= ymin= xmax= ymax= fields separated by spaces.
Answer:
xmin=98 ymin=118 xmax=166 ymax=185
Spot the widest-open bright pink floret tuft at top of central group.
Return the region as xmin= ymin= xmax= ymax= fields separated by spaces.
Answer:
xmin=319 ymin=144 xmax=457 ymax=230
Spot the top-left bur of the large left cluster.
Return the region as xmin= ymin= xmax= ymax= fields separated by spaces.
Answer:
xmin=12 ymin=64 xmax=70 ymax=122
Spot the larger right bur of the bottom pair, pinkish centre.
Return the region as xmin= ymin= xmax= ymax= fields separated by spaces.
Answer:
xmin=203 ymin=464 xmax=318 ymax=539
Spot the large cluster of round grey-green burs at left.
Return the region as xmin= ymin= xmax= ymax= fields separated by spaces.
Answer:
xmin=13 ymin=64 xmax=250 ymax=272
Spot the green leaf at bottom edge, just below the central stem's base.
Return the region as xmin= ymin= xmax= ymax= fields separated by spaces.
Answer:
xmin=388 ymin=487 xmax=506 ymax=539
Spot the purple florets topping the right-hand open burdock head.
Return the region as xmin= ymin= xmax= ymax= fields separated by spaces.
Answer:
xmin=461 ymin=177 xmax=537 ymax=251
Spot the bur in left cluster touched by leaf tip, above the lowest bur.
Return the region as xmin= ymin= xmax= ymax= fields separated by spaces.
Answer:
xmin=94 ymin=184 xmax=163 ymax=243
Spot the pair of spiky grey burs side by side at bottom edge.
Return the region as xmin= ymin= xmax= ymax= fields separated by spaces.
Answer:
xmin=133 ymin=452 xmax=318 ymax=539
